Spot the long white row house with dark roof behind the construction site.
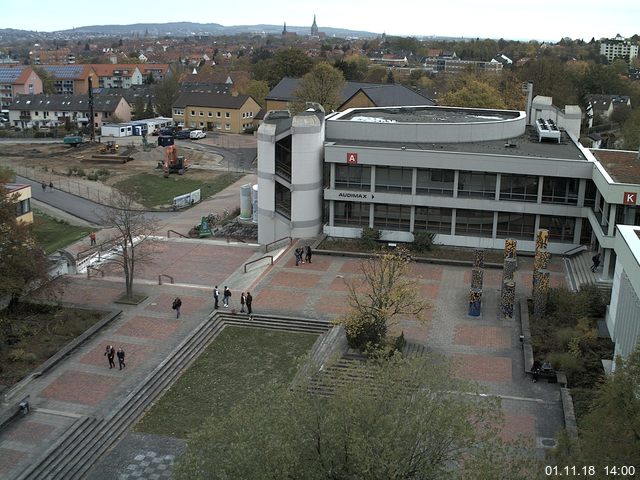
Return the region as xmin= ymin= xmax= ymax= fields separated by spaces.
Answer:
xmin=7 ymin=94 xmax=131 ymax=128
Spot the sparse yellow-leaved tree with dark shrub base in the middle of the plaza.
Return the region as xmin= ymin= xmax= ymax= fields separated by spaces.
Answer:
xmin=336 ymin=249 xmax=430 ymax=351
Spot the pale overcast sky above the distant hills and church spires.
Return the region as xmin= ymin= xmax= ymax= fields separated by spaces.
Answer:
xmin=5 ymin=0 xmax=640 ymax=41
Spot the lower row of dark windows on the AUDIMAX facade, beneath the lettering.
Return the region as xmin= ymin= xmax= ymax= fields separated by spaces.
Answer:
xmin=333 ymin=201 xmax=576 ymax=243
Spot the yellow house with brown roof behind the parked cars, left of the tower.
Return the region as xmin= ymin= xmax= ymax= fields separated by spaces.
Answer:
xmin=172 ymin=93 xmax=260 ymax=133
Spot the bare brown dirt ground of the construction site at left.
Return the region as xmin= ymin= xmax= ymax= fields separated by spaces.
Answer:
xmin=0 ymin=141 xmax=225 ymax=204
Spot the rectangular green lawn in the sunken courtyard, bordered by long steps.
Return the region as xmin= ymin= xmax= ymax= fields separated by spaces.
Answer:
xmin=135 ymin=327 xmax=317 ymax=438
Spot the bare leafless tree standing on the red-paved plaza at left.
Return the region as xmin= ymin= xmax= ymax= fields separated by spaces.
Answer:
xmin=101 ymin=190 xmax=157 ymax=298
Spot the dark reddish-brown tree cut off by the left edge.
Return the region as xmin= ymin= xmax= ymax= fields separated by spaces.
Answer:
xmin=0 ymin=170 xmax=49 ymax=310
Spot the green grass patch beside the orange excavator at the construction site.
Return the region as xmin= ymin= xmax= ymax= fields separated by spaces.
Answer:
xmin=114 ymin=172 xmax=240 ymax=208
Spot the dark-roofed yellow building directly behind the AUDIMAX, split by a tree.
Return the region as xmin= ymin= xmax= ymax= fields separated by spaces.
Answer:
xmin=265 ymin=77 xmax=434 ymax=112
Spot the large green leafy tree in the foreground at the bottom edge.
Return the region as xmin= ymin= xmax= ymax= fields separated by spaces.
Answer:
xmin=175 ymin=356 xmax=541 ymax=480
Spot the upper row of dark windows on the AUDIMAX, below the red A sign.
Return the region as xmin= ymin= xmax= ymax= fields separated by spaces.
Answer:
xmin=335 ymin=165 xmax=595 ymax=205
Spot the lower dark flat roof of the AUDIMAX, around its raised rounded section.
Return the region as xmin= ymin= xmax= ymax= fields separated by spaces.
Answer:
xmin=326 ymin=126 xmax=592 ymax=162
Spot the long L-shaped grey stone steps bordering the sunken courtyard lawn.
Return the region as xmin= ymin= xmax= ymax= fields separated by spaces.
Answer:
xmin=17 ymin=312 xmax=330 ymax=480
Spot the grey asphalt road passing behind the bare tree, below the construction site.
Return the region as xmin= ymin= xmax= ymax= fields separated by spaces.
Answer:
xmin=16 ymin=176 xmax=176 ymax=225
